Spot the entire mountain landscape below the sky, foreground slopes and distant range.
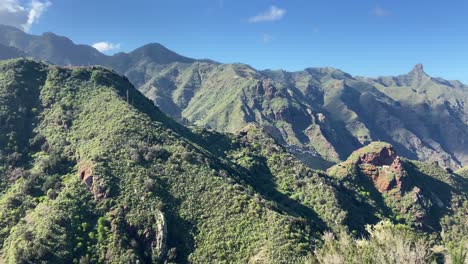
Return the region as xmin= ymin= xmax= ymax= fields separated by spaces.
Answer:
xmin=0 ymin=26 xmax=468 ymax=263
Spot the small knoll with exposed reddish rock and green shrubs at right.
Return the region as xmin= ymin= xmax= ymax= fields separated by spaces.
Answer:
xmin=327 ymin=142 xmax=468 ymax=230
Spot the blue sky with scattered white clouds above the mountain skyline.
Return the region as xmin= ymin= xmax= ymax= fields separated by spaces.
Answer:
xmin=0 ymin=0 xmax=468 ymax=83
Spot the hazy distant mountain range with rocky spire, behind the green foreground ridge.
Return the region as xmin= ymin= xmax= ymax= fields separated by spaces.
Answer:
xmin=0 ymin=26 xmax=468 ymax=169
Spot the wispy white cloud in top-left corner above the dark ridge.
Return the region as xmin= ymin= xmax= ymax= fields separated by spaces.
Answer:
xmin=0 ymin=0 xmax=52 ymax=32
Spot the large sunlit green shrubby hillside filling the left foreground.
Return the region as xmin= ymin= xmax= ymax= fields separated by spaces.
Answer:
xmin=0 ymin=60 xmax=318 ymax=263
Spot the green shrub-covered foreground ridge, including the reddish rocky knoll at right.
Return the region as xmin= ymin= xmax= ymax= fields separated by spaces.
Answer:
xmin=0 ymin=59 xmax=468 ymax=263
